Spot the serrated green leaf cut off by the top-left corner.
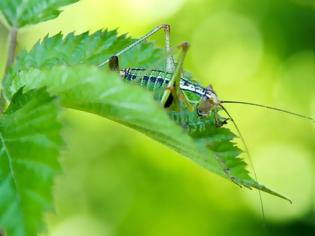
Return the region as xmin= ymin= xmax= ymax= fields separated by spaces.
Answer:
xmin=0 ymin=0 xmax=78 ymax=28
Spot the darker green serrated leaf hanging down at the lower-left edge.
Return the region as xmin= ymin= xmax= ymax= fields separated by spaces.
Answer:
xmin=0 ymin=89 xmax=61 ymax=236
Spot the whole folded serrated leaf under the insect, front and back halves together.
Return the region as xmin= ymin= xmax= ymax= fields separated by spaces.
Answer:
xmin=4 ymin=30 xmax=290 ymax=201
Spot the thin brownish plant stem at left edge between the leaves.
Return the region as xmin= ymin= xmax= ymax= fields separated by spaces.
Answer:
xmin=0 ymin=28 xmax=17 ymax=112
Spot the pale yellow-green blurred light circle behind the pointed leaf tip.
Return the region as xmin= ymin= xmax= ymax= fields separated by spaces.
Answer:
xmin=244 ymin=144 xmax=313 ymax=221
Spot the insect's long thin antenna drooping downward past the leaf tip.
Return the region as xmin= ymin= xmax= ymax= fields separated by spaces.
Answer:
xmin=219 ymin=104 xmax=267 ymax=233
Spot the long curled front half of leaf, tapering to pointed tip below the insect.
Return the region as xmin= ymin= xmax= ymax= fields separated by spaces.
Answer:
xmin=6 ymin=66 xmax=294 ymax=203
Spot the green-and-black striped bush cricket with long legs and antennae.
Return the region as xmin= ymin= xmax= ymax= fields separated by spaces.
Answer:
xmin=99 ymin=24 xmax=315 ymax=192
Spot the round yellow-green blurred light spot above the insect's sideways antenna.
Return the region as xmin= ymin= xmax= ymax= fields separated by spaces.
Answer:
xmin=192 ymin=12 xmax=263 ymax=85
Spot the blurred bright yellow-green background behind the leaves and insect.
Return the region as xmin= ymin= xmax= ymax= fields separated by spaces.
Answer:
xmin=0 ymin=0 xmax=315 ymax=236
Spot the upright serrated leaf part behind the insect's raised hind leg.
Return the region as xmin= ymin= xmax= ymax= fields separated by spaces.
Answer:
xmin=6 ymin=30 xmax=163 ymax=84
